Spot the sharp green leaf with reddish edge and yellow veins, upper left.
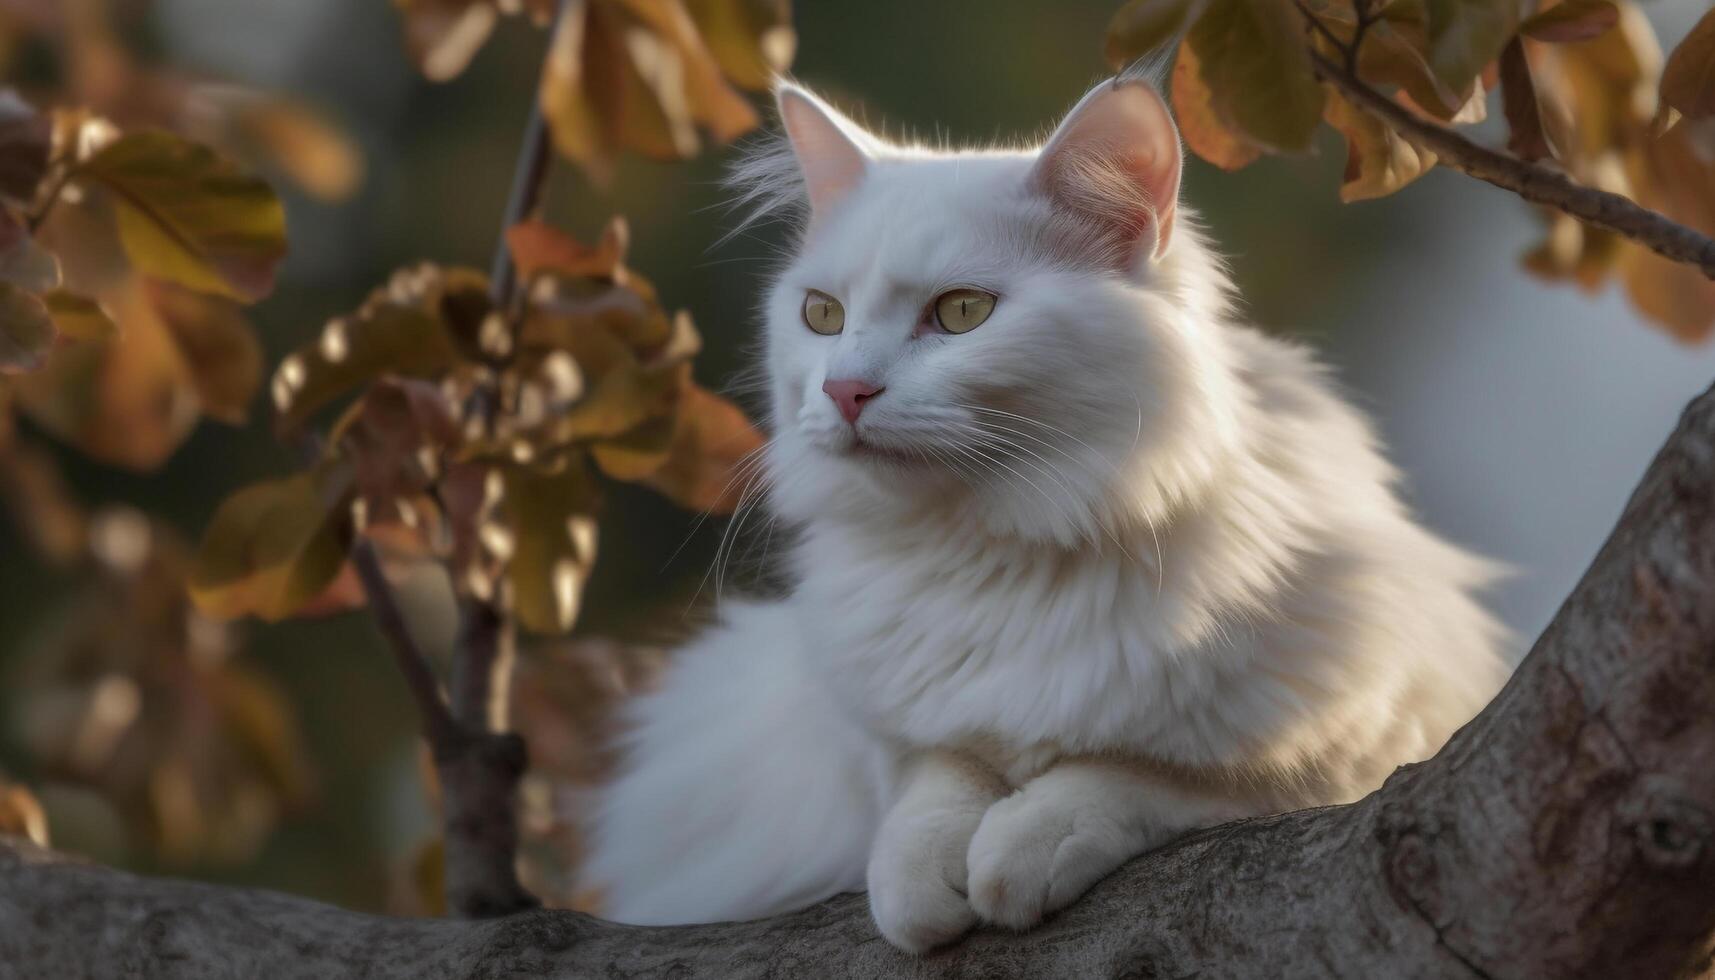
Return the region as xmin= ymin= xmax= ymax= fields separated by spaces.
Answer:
xmin=75 ymin=130 xmax=286 ymax=302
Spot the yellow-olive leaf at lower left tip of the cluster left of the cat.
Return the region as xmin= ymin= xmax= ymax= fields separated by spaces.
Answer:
xmin=190 ymin=463 xmax=352 ymax=621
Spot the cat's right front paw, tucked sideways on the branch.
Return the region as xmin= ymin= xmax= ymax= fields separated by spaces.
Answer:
xmin=966 ymin=786 xmax=1135 ymax=929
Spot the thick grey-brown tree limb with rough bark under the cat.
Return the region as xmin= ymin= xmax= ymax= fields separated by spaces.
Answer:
xmin=0 ymin=386 xmax=1715 ymax=980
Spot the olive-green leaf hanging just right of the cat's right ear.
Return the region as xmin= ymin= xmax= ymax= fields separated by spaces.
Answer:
xmin=1187 ymin=0 xmax=1322 ymax=153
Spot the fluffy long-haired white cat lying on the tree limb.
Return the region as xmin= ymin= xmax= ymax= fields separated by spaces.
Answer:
xmin=587 ymin=77 xmax=1504 ymax=951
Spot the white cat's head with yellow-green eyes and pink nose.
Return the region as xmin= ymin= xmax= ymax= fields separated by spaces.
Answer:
xmin=737 ymin=77 xmax=1231 ymax=544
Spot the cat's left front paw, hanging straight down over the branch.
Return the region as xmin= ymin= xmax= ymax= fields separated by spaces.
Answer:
xmin=868 ymin=814 xmax=976 ymax=954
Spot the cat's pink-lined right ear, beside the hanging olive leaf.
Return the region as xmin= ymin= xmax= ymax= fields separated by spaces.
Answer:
xmin=1031 ymin=77 xmax=1183 ymax=264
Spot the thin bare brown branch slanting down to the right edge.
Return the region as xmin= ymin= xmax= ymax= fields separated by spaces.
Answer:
xmin=1310 ymin=50 xmax=1715 ymax=280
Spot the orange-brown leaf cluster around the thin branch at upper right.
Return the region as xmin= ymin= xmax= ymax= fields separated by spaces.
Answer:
xmin=1106 ymin=0 xmax=1715 ymax=342
